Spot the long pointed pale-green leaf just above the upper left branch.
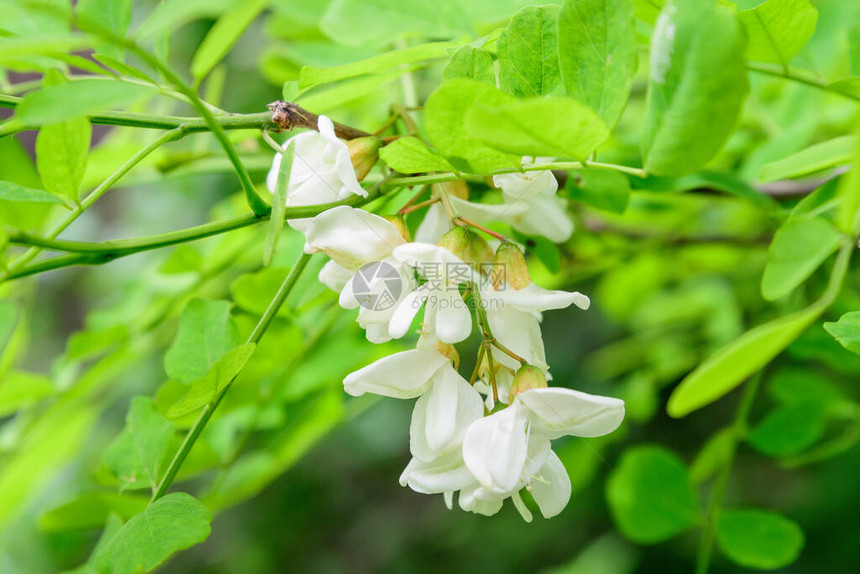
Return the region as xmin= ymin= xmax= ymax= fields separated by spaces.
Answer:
xmin=14 ymin=79 xmax=155 ymax=127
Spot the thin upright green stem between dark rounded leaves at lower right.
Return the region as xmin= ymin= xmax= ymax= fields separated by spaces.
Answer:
xmin=696 ymin=371 xmax=762 ymax=574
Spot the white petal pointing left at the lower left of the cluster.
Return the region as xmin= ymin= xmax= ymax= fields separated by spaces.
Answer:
xmin=343 ymin=349 xmax=448 ymax=399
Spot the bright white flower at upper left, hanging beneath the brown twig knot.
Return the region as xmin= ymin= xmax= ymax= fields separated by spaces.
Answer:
xmin=266 ymin=116 xmax=367 ymax=231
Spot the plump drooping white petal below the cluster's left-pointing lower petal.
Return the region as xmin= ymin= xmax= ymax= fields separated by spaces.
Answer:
xmin=409 ymin=363 xmax=484 ymax=460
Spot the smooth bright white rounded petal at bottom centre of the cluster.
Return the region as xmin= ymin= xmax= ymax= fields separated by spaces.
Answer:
xmin=463 ymin=401 xmax=528 ymax=493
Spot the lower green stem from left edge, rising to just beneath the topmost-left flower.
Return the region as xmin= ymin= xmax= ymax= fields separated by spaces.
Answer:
xmin=0 ymin=188 xmax=380 ymax=283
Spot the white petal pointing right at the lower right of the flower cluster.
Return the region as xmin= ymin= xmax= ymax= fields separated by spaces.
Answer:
xmin=514 ymin=387 xmax=624 ymax=439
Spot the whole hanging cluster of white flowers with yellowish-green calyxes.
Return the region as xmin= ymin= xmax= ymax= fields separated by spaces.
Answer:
xmin=269 ymin=116 xmax=624 ymax=520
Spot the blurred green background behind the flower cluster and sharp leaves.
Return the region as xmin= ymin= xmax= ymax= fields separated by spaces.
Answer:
xmin=0 ymin=0 xmax=860 ymax=574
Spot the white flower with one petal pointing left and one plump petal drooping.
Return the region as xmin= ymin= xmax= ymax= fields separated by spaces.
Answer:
xmin=343 ymin=349 xmax=484 ymax=462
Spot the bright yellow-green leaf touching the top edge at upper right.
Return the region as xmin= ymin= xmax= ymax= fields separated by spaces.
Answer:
xmin=738 ymin=0 xmax=818 ymax=67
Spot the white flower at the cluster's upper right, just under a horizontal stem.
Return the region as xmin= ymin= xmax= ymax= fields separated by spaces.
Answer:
xmin=493 ymin=156 xmax=573 ymax=243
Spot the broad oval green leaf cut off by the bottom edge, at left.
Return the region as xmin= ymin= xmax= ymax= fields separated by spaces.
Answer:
xmin=94 ymin=492 xmax=212 ymax=574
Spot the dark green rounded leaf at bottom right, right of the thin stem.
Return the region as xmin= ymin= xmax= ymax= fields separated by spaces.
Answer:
xmin=717 ymin=509 xmax=803 ymax=570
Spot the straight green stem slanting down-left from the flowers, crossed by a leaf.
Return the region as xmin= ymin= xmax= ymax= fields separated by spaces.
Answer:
xmin=150 ymin=253 xmax=311 ymax=504
